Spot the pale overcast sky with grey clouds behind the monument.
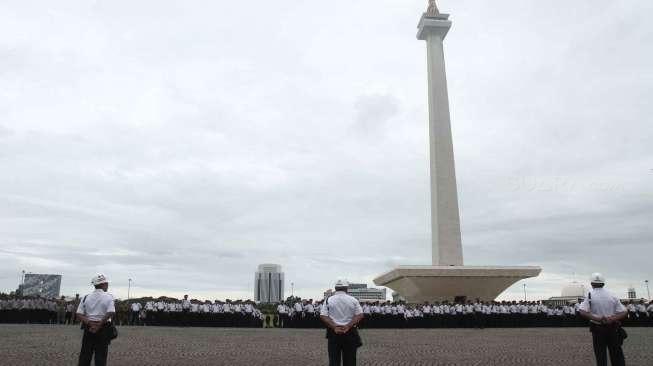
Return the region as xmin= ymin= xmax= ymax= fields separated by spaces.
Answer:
xmin=0 ymin=0 xmax=653 ymax=299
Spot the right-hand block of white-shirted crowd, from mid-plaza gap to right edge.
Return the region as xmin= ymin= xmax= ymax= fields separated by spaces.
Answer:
xmin=277 ymin=300 xmax=653 ymax=328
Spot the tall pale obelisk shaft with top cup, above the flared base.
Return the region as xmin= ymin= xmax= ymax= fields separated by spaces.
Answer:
xmin=417 ymin=3 xmax=463 ymax=266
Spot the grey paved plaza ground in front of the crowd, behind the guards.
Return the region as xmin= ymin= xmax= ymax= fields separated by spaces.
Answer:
xmin=0 ymin=325 xmax=653 ymax=366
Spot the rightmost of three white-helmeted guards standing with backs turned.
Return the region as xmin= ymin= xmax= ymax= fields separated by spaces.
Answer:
xmin=580 ymin=273 xmax=627 ymax=366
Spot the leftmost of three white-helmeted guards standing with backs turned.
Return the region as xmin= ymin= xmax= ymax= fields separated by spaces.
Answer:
xmin=77 ymin=274 xmax=116 ymax=366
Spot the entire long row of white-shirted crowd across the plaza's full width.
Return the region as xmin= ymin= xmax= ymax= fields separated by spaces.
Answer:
xmin=0 ymin=296 xmax=653 ymax=328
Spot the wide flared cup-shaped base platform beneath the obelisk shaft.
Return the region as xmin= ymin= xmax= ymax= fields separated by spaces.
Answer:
xmin=374 ymin=266 xmax=542 ymax=303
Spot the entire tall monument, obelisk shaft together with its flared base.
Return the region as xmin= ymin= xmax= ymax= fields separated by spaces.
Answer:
xmin=374 ymin=0 xmax=542 ymax=302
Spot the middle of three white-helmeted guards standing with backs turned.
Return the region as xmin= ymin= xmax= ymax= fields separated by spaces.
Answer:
xmin=320 ymin=280 xmax=363 ymax=366
